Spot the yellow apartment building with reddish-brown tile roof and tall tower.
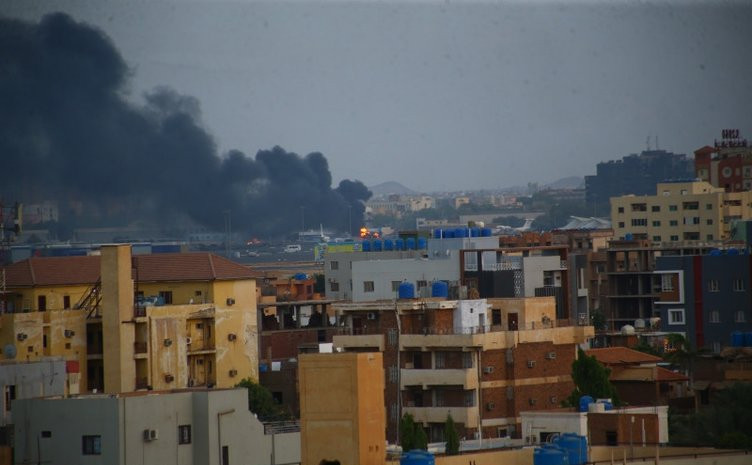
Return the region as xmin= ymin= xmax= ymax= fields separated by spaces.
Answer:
xmin=0 ymin=245 xmax=258 ymax=393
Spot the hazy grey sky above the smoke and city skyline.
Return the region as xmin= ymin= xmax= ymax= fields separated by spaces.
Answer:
xmin=0 ymin=0 xmax=752 ymax=191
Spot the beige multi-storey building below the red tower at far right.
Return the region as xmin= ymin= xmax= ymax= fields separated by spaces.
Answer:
xmin=611 ymin=181 xmax=752 ymax=243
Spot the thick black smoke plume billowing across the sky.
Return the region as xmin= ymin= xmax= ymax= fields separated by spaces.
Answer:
xmin=0 ymin=13 xmax=371 ymax=235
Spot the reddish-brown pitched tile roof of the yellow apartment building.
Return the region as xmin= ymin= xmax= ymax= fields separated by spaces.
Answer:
xmin=4 ymin=252 xmax=258 ymax=288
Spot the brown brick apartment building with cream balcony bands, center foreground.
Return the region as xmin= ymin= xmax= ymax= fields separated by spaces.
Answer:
xmin=333 ymin=297 xmax=593 ymax=442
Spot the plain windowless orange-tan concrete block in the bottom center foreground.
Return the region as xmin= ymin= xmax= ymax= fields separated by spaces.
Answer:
xmin=299 ymin=353 xmax=386 ymax=465
